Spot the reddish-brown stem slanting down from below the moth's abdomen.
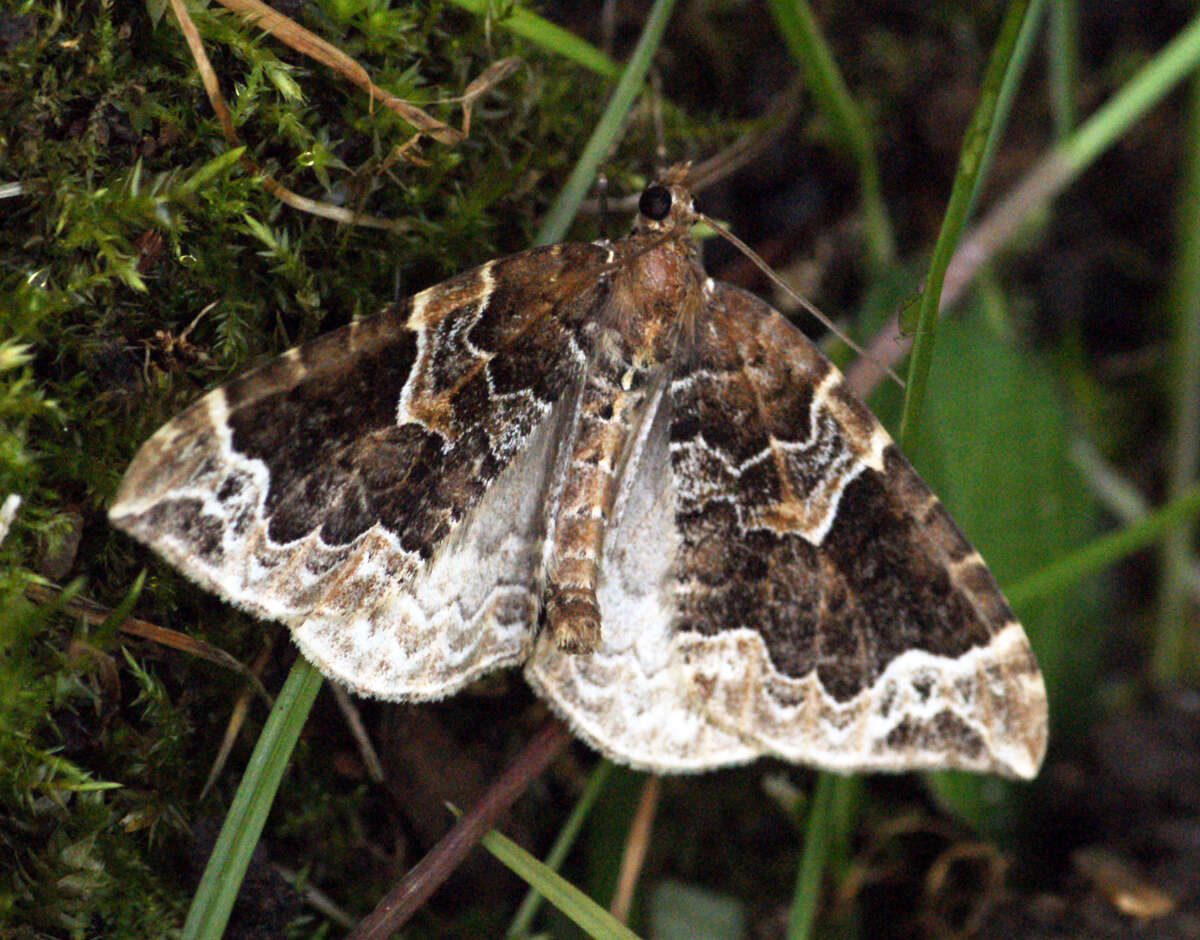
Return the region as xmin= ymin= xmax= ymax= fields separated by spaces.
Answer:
xmin=347 ymin=719 xmax=571 ymax=940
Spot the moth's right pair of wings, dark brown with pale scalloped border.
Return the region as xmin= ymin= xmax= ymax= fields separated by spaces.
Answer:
xmin=527 ymin=282 xmax=1046 ymax=777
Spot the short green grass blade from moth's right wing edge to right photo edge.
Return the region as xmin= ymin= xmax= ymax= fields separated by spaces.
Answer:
xmin=1004 ymin=484 xmax=1200 ymax=605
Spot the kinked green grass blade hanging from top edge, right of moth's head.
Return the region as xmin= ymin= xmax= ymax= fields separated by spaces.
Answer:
xmin=768 ymin=0 xmax=895 ymax=270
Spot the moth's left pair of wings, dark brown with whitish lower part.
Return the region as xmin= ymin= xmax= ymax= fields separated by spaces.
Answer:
xmin=110 ymin=245 xmax=610 ymax=699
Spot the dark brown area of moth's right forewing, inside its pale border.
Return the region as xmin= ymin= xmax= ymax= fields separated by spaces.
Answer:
xmin=671 ymin=285 xmax=1007 ymax=701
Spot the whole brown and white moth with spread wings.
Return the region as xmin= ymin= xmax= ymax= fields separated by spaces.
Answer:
xmin=110 ymin=167 xmax=1046 ymax=778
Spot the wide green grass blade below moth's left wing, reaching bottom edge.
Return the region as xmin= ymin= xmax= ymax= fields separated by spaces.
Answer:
xmin=184 ymin=657 xmax=322 ymax=940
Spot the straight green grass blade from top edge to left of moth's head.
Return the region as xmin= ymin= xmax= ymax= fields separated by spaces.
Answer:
xmin=535 ymin=0 xmax=674 ymax=245
